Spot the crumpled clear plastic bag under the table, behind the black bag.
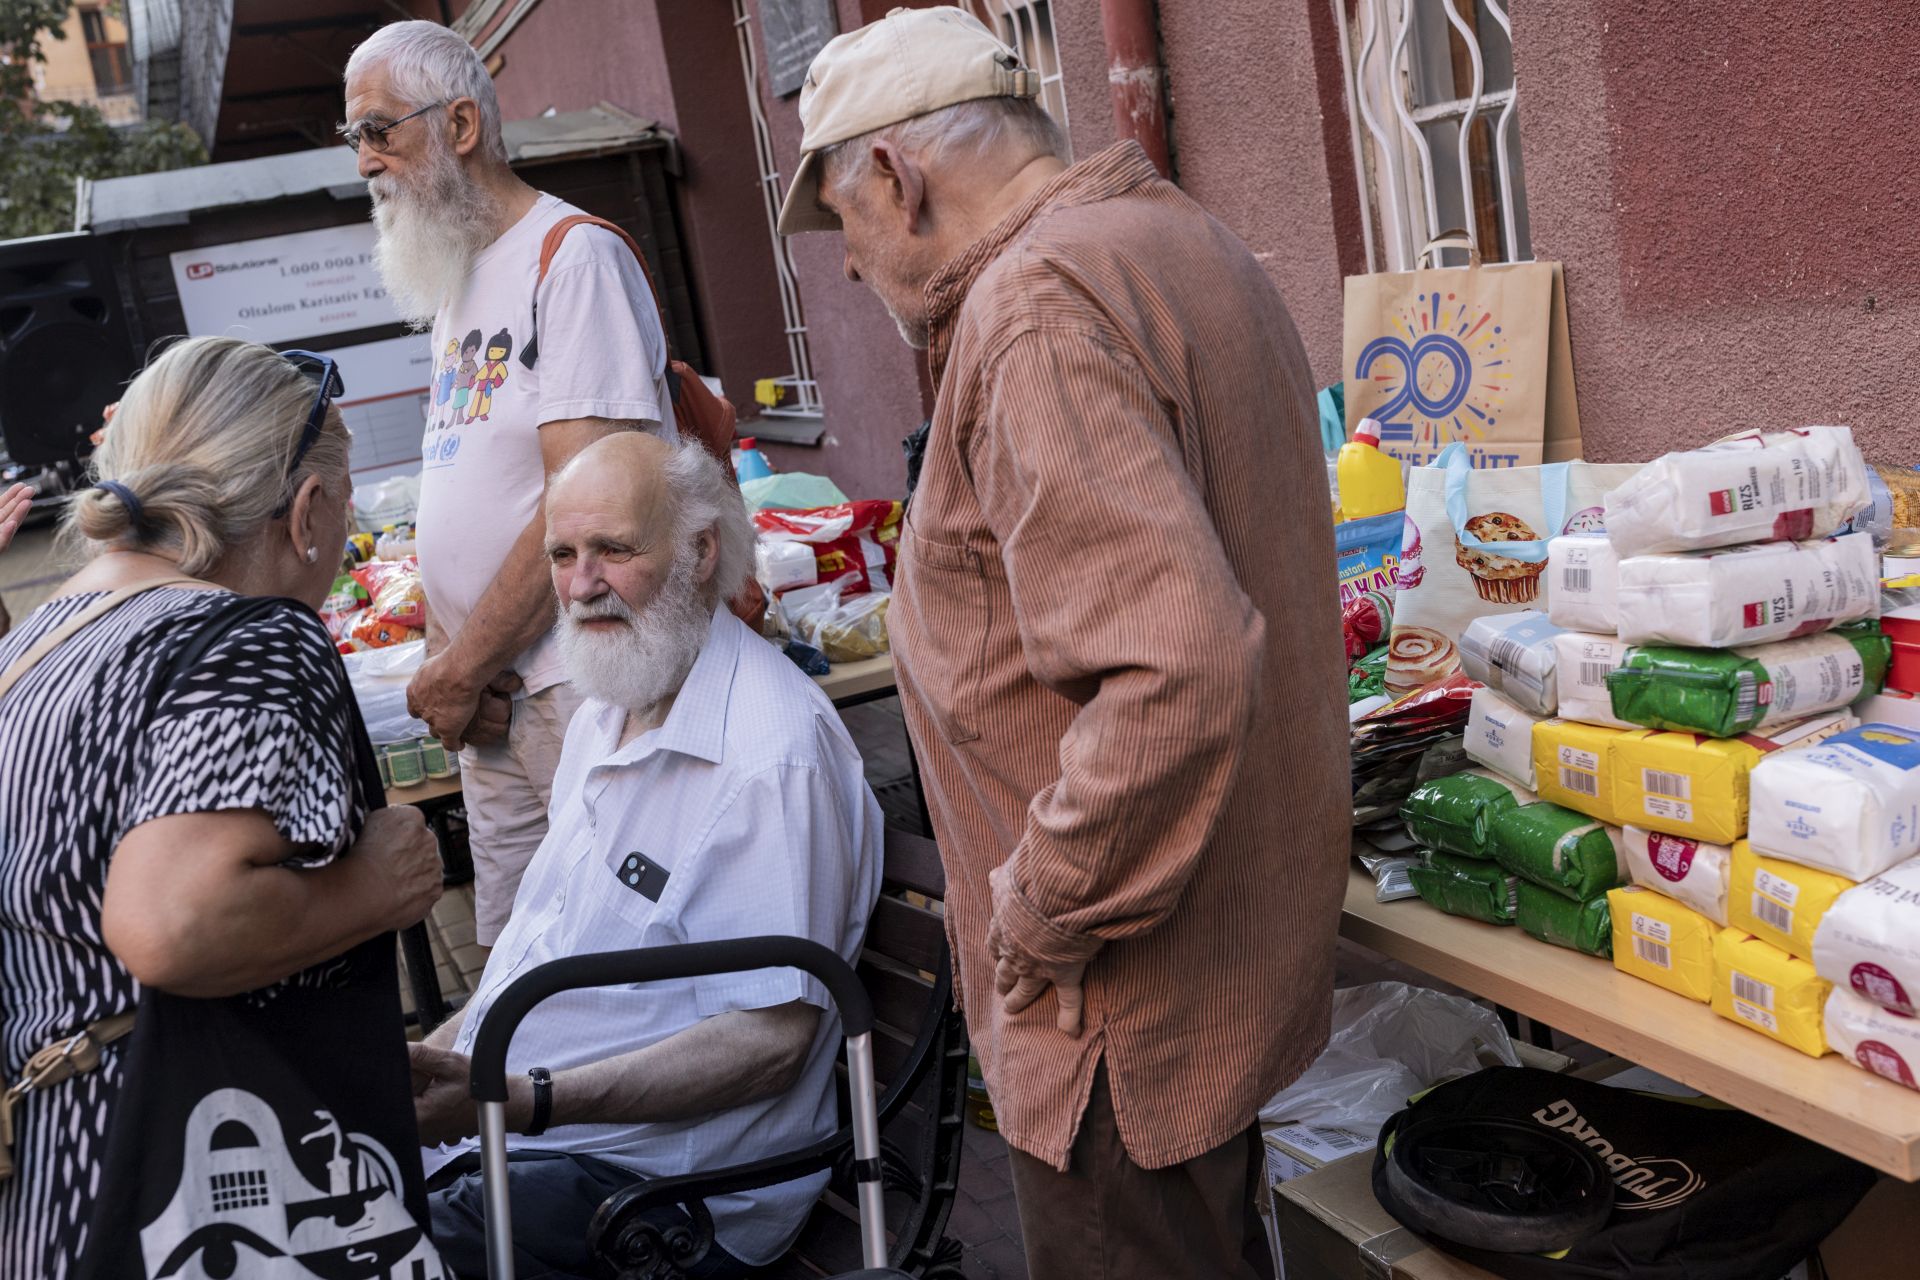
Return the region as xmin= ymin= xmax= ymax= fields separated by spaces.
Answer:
xmin=1260 ymin=983 xmax=1521 ymax=1140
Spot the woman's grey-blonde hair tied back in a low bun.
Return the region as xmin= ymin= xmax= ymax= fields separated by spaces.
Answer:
xmin=61 ymin=338 xmax=348 ymax=574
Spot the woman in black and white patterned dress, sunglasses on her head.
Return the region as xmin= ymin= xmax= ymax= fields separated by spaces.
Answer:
xmin=0 ymin=338 xmax=444 ymax=1280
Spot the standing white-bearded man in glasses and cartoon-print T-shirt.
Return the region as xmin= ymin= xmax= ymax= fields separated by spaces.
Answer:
xmin=342 ymin=21 xmax=674 ymax=946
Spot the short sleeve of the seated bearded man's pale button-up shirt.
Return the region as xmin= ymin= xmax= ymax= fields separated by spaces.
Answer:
xmin=676 ymin=764 xmax=872 ymax=1017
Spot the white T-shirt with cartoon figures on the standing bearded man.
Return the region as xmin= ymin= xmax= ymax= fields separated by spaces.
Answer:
xmin=415 ymin=196 xmax=674 ymax=693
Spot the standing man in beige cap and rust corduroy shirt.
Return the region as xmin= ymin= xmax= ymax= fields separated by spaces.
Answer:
xmin=781 ymin=8 xmax=1350 ymax=1280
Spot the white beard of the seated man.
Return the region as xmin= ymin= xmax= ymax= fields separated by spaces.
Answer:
xmin=557 ymin=549 xmax=712 ymax=716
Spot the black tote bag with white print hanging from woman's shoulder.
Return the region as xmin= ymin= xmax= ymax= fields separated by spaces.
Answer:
xmin=77 ymin=597 xmax=447 ymax=1280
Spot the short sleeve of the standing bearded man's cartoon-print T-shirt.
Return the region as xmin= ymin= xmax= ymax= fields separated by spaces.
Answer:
xmin=536 ymin=226 xmax=670 ymax=426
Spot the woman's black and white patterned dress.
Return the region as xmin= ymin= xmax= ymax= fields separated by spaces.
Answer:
xmin=0 ymin=587 xmax=367 ymax=1280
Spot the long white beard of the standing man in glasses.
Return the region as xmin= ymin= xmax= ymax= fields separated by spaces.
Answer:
xmin=367 ymin=136 xmax=499 ymax=330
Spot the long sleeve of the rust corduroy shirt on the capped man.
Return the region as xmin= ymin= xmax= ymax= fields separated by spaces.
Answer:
xmin=972 ymin=326 xmax=1265 ymax=963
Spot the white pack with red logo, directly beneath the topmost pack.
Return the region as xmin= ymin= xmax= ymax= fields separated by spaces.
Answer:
xmin=1619 ymin=533 xmax=1880 ymax=649
